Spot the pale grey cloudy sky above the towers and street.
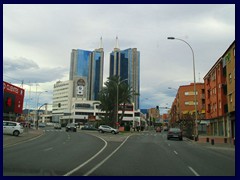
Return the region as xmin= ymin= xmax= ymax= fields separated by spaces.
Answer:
xmin=3 ymin=4 xmax=235 ymax=112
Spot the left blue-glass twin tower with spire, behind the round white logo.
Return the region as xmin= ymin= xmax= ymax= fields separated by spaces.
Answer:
xmin=69 ymin=38 xmax=104 ymax=100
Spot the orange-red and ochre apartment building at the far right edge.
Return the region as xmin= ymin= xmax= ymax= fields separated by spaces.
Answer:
xmin=204 ymin=41 xmax=235 ymax=142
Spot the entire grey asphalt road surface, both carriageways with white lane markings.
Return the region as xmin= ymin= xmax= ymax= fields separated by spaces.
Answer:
xmin=3 ymin=129 xmax=235 ymax=176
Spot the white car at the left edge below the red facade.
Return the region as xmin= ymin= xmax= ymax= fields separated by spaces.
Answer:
xmin=3 ymin=121 xmax=23 ymax=136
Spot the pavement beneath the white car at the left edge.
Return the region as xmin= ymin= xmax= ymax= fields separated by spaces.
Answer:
xmin=3 ymin=128 xmax=44 ymax=148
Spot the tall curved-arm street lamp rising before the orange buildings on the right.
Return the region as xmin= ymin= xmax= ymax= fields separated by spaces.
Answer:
xmin=167 ymin=37 xmax=198 ymax=141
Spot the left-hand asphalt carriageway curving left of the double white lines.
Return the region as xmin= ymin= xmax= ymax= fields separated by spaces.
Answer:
xmin=3 ymin=130 xmax=104 ymax=176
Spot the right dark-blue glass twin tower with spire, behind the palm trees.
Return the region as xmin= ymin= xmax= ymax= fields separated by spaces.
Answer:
xmin=109 ymin=37 xmax=140 ymax=110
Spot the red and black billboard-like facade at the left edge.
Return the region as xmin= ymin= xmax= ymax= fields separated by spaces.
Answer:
xmin=3 ymin=81 xmax=25 ymax=114
